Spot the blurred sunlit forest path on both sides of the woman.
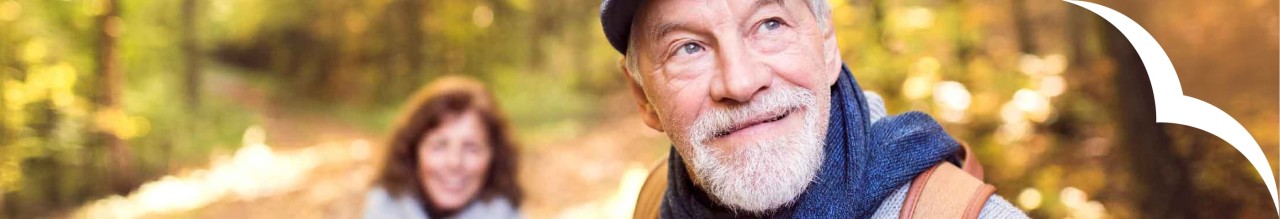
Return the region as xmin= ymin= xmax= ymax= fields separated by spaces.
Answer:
xmin=72 ymin=72 xmax=667 ymax=219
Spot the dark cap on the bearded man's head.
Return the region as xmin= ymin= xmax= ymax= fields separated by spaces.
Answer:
xmin=600 ymin=0 xmax=644 ymax=54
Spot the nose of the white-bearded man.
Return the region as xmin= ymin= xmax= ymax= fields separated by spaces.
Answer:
xmin=710 ymin=44 xmax=773 ymax=102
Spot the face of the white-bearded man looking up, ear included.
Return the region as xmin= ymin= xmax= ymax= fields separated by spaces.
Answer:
xmin=626 ymin=0 xmax=840 ymax=213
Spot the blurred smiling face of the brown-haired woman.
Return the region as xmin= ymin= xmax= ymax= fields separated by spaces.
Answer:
xmin=417 ymin=111 xmax=493 ymax=210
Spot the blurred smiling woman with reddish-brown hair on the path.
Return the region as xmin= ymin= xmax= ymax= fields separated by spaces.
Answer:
xmin=365 ymin=77 xmax=522 ymax=218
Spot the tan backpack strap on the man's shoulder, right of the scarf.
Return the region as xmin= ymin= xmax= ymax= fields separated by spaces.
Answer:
xmin=899 ymin=146 xmax=996 ymax=219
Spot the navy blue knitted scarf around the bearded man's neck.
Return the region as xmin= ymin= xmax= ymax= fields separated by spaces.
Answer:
xmin=662 ymin=67 xmax=960 ymax=218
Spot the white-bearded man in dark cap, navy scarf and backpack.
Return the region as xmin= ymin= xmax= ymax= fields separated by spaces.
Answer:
xmin=600 ymin=0 xmax=1025 ymax=218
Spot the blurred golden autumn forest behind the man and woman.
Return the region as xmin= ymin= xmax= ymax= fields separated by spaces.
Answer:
xmin=0 ymin=0 xmax=1280 ymax=218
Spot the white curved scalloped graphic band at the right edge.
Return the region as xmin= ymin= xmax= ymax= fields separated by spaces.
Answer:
xmin=1064 ymin=0 xmax=1280 ymax=214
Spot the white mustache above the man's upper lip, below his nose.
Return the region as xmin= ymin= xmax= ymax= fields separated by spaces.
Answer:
xmin=689 ymin=87 xmax=817 ymax=142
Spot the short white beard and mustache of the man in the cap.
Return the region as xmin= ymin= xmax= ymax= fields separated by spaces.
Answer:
xmin=682 ymin=87 xmax=824 ymax=214
